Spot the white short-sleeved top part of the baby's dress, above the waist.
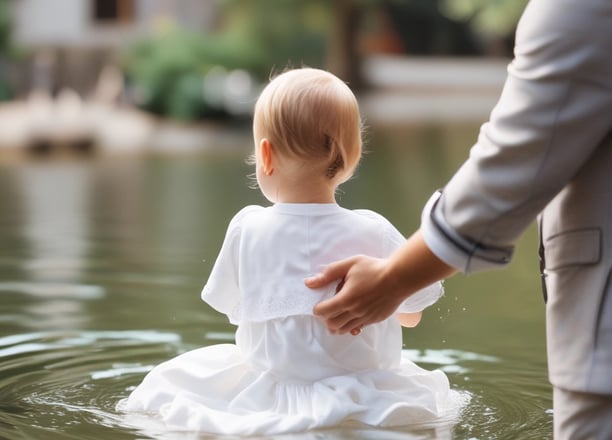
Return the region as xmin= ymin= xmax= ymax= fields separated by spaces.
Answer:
xmin=202 ymin=203 xmax=442 ymax=324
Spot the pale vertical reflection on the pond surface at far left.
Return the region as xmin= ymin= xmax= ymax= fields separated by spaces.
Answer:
xmin=0 ymin=162 xmax=105 ymax=329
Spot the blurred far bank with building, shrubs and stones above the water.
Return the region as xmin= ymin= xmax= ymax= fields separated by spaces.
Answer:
xmin=0 ymin=0 xmax=526 ymax=155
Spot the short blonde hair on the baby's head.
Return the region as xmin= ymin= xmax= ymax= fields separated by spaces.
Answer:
xmin=253 ymin=68 xmax=362 ymax=181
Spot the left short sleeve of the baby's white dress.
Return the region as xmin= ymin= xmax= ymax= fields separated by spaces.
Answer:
xmin=202 ymin=206 xmax=261 ymax=322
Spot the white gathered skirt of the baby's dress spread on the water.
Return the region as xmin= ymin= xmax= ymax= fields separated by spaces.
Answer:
xmin=119 ymin=315 xmax=459 ymax=435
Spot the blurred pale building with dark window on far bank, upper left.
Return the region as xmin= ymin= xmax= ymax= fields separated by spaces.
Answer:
xmin=10 ymin=0 xmax=217 ymax=95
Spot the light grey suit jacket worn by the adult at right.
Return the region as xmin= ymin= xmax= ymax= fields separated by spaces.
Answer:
xmin=422 ymin=0 xmax=612 ymax=394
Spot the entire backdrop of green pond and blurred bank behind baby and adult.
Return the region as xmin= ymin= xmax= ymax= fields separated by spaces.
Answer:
xmin=0 ymin=0 xmax=552 ymax=440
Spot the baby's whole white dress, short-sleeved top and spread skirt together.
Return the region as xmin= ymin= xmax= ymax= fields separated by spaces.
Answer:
xmin=118 ymin=204 xmax=452 ymax=435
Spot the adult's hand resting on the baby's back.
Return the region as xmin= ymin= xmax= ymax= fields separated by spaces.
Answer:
xmin=305 ymin=255 xmax=404 ymax=335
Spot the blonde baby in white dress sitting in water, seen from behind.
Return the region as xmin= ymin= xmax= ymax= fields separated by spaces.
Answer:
xmin=119 ymin=68 xmax=451 ymax=435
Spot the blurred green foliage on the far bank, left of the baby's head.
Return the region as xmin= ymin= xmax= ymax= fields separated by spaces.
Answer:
xmin=120 ymin=0 xmax=331 ymax=120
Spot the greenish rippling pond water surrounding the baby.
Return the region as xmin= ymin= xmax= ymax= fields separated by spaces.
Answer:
xmin=0 ymin=127 xmax=552 ymax=440
